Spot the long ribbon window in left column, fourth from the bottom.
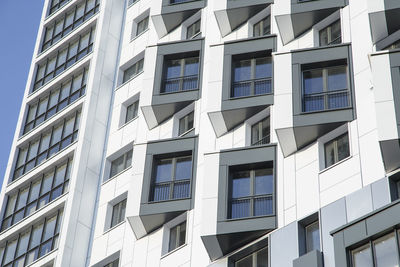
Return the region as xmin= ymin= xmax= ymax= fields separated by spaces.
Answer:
xmin=23 ymin=69 xmax=88 ymax=134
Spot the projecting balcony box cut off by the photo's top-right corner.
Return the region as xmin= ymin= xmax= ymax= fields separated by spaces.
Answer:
xmin=367 ymin=0 xmax=400 ymax=43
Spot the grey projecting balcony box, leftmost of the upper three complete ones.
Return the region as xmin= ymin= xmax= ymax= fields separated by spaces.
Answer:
xmin=142 ymin=39 xmax=204 ymax=129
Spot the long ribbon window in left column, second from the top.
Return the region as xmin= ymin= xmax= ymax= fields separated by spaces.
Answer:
xmin=41 ymin=0 xmax=100 ymax=51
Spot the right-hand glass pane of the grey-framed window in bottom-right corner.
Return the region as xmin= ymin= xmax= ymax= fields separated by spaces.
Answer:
xmin=374 ymin=233 xmax=399 ymax=267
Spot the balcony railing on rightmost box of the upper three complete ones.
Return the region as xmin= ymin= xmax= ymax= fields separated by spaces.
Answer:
xmin=303 ymin=89 xmax=350 ymax=112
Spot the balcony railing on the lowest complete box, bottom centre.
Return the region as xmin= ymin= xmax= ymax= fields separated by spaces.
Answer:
xmin=230 ymin=195 xmax=274 ymax=219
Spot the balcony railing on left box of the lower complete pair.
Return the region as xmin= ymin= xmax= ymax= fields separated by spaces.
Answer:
xmin=152 ymin=180 xmax=190 ymax=201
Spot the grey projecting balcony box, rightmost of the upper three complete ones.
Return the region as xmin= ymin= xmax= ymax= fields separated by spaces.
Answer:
xmin=274 ymin=44 xmax=356 ymax=157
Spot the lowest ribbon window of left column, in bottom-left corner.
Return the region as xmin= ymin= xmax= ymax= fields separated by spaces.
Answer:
xmin=0 ymin=210 xmax=63 ymax=267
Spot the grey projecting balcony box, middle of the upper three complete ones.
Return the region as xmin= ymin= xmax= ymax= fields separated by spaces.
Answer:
xmin=208 ymin=35 xmax=276 ymax=137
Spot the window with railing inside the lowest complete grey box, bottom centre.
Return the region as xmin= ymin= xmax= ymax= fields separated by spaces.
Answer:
xmin=229 ymin=167 xmax=274 ymax=219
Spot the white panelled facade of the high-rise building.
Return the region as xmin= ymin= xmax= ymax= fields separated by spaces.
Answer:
xmin=0 ymin=0 xmax=400 ymax=267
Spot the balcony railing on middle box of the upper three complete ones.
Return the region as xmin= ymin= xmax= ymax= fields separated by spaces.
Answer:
xmin=231 ymin=78 xmax=272 ymax=98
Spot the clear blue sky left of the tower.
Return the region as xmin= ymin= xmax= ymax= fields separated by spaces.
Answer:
xmin=0 ymin=0 xmax=44 ymax=184
